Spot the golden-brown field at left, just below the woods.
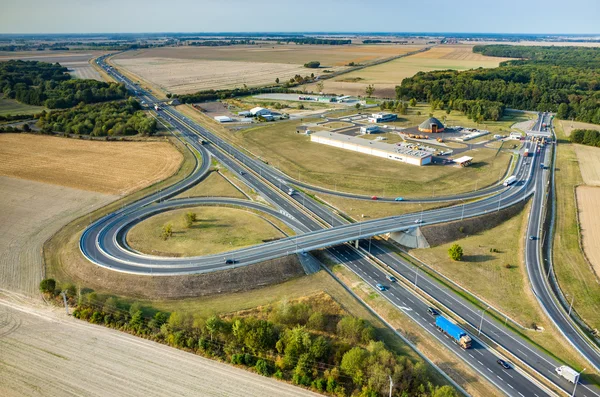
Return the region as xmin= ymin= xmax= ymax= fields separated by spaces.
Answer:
xmin=0 ymin=134 xmax=182 ymax=195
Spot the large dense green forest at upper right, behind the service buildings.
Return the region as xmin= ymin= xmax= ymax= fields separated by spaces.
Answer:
xmin=396 ymin=45 xmax=600 ymax=124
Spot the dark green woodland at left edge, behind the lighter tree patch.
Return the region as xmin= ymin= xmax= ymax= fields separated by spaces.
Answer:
xmin=0 ymin=60 xmax=127 ymax=109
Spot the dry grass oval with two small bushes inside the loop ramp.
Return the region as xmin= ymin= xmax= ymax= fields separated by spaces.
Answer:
xmin=127 ymin=206 xmax=285 ymax=256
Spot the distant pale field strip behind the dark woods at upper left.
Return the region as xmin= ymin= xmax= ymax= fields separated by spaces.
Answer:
xmin=0 ymin=51 xmax=104 ymax=81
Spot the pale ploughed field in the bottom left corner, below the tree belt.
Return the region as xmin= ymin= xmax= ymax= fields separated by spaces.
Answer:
xmin=0 ymin=294 xmax=317 ymax=397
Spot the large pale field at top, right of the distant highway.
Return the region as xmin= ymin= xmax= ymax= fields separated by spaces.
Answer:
xmin=113 ymin=45 xmax=421 ymax=94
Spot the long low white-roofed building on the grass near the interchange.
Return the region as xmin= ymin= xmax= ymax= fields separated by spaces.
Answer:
xmin=310 ymin=131 xmax=431 ymax=165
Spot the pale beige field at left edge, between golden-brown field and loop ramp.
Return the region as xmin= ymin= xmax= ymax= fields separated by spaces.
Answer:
xmin=0 ymin=176 xmax=116 ymax=294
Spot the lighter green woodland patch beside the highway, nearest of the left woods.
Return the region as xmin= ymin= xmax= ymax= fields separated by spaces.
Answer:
xmin=37 ymin=98 xmax=156 ymax=136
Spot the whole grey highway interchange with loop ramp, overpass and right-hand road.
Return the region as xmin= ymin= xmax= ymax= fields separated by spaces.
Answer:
xmin=88 ymin=54 xmax=600 ymax=396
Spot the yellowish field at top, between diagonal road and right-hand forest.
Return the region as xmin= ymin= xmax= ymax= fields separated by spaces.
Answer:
xmin=311 ymin=45 xmax=506 ymax=98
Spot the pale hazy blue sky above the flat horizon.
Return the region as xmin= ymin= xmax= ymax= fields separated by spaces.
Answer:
xmin=0 ymin=0 xmax=600 ymax=34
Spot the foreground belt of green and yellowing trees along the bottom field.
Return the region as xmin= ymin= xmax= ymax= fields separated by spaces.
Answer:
xmin=40 ymin=279 xmax=457 ymax=397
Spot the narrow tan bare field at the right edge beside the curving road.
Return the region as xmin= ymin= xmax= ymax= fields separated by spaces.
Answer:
xmin=577 ymin=186 xmax=600 ymax=277
